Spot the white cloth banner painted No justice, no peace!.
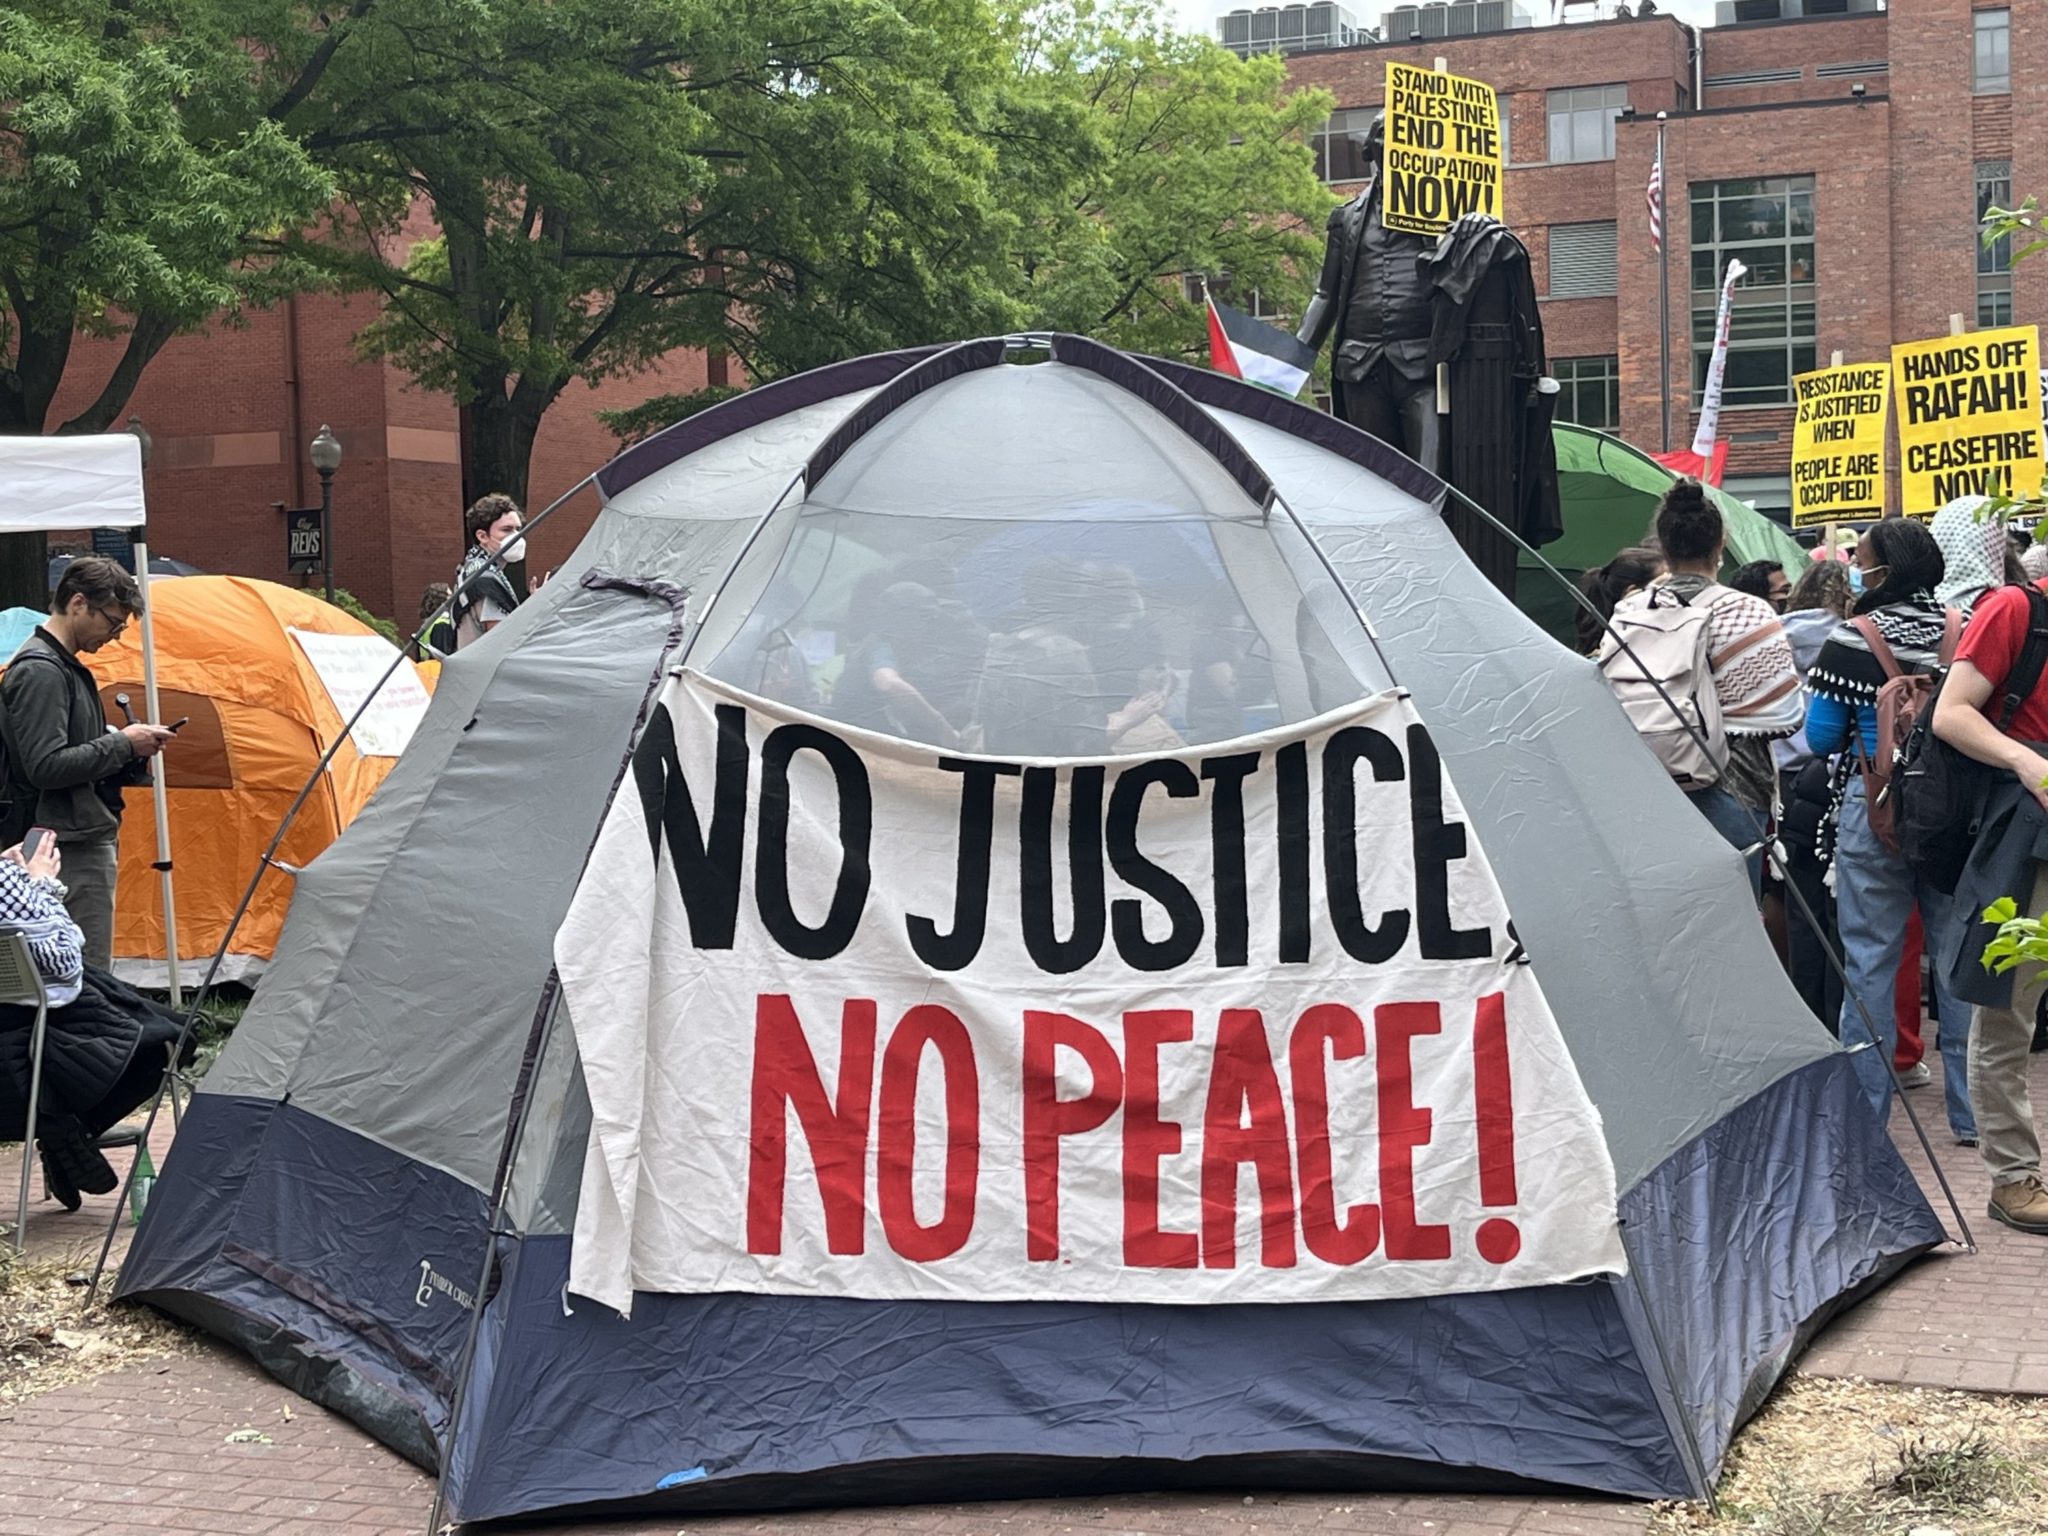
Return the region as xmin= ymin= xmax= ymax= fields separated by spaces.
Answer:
xmin=555 ymin=672 xmax=1624 ymax=1313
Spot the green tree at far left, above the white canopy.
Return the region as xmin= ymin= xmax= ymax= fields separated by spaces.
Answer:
xmin=0 ymin=0 xmax=330 ymax=606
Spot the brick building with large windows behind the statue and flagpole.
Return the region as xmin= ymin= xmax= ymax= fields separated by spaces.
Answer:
xmin=1269 ymin=0 xmax=2048 ymax=516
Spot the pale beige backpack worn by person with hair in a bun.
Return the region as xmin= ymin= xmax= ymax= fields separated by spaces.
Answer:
xmin=1599 ymin=586 xmax=1729 ymax=788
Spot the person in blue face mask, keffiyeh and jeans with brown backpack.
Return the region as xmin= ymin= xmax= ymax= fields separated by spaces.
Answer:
xmin=1806 ymin=518 xmax=1974 ymax=1147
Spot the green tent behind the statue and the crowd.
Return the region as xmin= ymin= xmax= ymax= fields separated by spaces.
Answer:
xmin=1516 ymin=422 xmax=1808 ymax=645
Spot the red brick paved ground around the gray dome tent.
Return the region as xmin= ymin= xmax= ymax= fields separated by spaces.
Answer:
xmin=0 ymin=1057 xmax=2048 ymax=1536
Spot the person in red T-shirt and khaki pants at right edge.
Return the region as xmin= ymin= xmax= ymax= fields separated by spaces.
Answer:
xmin=1933 ymin=582 xmax=2048 ymax=1237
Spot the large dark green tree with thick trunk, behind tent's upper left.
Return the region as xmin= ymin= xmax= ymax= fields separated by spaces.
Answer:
xmin=289 ymin=0 xmax=1012 ymax=498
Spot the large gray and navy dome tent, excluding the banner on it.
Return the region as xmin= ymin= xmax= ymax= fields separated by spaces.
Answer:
xmin=121 ymin=338 xmax=1944 ymax=1520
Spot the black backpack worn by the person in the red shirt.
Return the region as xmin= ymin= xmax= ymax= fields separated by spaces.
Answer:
xmin=1888 ymin=584 xmax=2048 ymax=893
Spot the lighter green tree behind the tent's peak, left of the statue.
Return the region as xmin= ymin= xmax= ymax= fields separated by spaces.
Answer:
xmin=1001 ymin=0 xmax=1335 ymax=356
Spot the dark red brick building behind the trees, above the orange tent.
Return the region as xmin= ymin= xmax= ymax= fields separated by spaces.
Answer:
xmin=51 ymin=246 xmax=723 ymax=625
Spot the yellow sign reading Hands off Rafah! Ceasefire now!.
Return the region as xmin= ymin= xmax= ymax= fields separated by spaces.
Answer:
xmin=1892 ymin=326 xmax=2042 ymax=516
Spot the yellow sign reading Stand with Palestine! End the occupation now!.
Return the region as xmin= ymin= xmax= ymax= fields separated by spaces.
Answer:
xmin=1380 ymin=59 xmax=1501 ymax=236
